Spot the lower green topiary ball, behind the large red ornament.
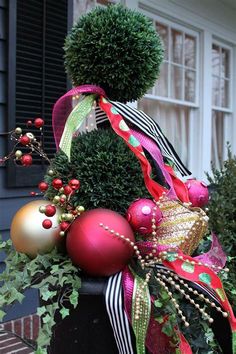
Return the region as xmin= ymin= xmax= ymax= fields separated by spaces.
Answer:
xmin=46 ymin=129 xmax=150 ymax=214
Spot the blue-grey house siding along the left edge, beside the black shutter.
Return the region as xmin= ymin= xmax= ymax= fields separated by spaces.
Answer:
xmin=0 ymin=0 xmax=37 ymax=321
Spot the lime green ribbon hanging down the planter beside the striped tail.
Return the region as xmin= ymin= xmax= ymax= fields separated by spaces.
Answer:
xmin=131 ymin=273 xmax=151 ymax=354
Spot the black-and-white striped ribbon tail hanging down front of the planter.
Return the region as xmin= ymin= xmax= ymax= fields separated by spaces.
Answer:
xmin=105 ymin=272 xmax=135 ymax=354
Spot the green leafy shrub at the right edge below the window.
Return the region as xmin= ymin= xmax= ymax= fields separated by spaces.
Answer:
xmin=207 ymin=147 xmax=236 ymax=310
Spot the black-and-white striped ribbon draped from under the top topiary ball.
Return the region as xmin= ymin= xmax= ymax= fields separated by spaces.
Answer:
xmin=95 ymin=101 xmax=191 ymax=176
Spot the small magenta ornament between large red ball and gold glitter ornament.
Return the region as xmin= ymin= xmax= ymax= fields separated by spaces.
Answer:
xmin=126 ymin=198 xmax=162 ymax=235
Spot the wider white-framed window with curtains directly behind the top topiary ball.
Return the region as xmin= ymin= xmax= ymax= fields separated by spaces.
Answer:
xmin=138 ymin=18 xmax=199 ymax=167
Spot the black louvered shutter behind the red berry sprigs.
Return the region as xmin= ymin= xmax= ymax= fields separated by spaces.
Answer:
xmin=8 ymin=0 xmax=70 ymax=187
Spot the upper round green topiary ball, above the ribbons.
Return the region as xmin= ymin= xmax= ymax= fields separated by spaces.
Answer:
xmin=64 ymin=5 xmax=163 ymax=102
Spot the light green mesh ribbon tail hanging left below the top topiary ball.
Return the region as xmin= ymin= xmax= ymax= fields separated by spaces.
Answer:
xmin=59 ymin=95 xmax=96 ymax=161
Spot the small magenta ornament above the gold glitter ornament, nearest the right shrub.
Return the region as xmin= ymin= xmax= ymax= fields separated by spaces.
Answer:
xmin=185 ymin=179 xmax=209 ymax=208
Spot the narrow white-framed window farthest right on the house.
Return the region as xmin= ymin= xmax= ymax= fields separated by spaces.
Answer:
xmin=211 ymin=41 xmax=232 ymax=169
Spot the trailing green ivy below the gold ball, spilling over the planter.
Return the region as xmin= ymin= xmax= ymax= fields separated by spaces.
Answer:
xmin=0 ymin=241 xmax=81 ymax=354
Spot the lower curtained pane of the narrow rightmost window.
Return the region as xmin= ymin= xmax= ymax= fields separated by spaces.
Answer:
xmin=211 ymin=111 xmax=224 ymax=169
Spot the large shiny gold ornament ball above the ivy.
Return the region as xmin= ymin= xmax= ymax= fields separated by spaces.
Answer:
xmin=10 ymin=200 xmax=61 ymax=258
